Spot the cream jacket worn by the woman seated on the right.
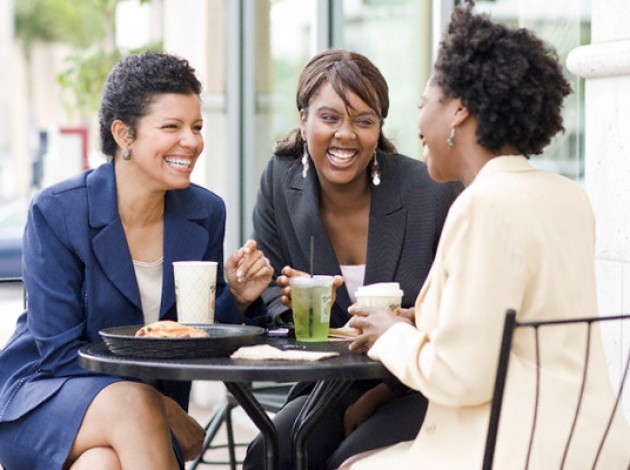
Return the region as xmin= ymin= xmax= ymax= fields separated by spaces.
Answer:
xmin=352 ymin=156 xmax=630 ymax=470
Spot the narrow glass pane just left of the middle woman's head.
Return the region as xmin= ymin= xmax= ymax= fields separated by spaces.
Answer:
xmin=242 ymin=0 xmax=317 ymax=238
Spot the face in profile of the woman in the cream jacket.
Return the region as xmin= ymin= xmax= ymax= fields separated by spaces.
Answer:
xmin=418 ymin=80 xmax=459 ymax=181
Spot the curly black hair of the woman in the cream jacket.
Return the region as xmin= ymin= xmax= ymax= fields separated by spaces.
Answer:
xmin=432 ymin=2 xmax=571 ymax=156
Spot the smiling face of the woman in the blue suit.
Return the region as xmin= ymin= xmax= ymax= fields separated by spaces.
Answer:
xmin=127 ymin=93 xmax=203 ymax=191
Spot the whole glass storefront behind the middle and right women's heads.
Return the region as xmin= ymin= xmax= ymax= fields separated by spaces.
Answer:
xmin=238 ymin=0 xmax=590 ymax=244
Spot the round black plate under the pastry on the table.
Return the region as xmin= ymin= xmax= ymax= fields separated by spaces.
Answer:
xmin=99 ymin=324 xmax=265 ymax=359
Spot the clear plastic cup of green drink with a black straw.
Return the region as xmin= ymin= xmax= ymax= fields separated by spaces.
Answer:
xmin=289 ymin=276 xmax=334 ymax=341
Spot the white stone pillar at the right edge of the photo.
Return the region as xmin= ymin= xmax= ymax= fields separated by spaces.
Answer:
xmin=567 ymin=0 xmax=630 ymax=416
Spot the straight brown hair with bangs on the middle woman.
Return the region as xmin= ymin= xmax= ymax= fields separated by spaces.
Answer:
xmin=274 ymin=49 xmax=396 ymax=155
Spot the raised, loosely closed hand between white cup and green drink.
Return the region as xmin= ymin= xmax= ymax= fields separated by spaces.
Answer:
xmin=225 ymin=240 xmax=273 ymax=312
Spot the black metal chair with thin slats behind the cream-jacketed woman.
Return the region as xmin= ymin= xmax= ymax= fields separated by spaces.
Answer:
xmin=482 ymin=309 xmax=630 ymax=470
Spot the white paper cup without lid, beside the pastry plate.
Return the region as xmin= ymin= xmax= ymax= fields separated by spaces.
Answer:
xmin=173 ymin=261 xmax=218 ymax=324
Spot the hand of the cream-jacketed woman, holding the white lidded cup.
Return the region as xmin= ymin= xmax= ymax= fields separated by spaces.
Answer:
xmin=348 ymin=304 xmax=413 ymax=351
